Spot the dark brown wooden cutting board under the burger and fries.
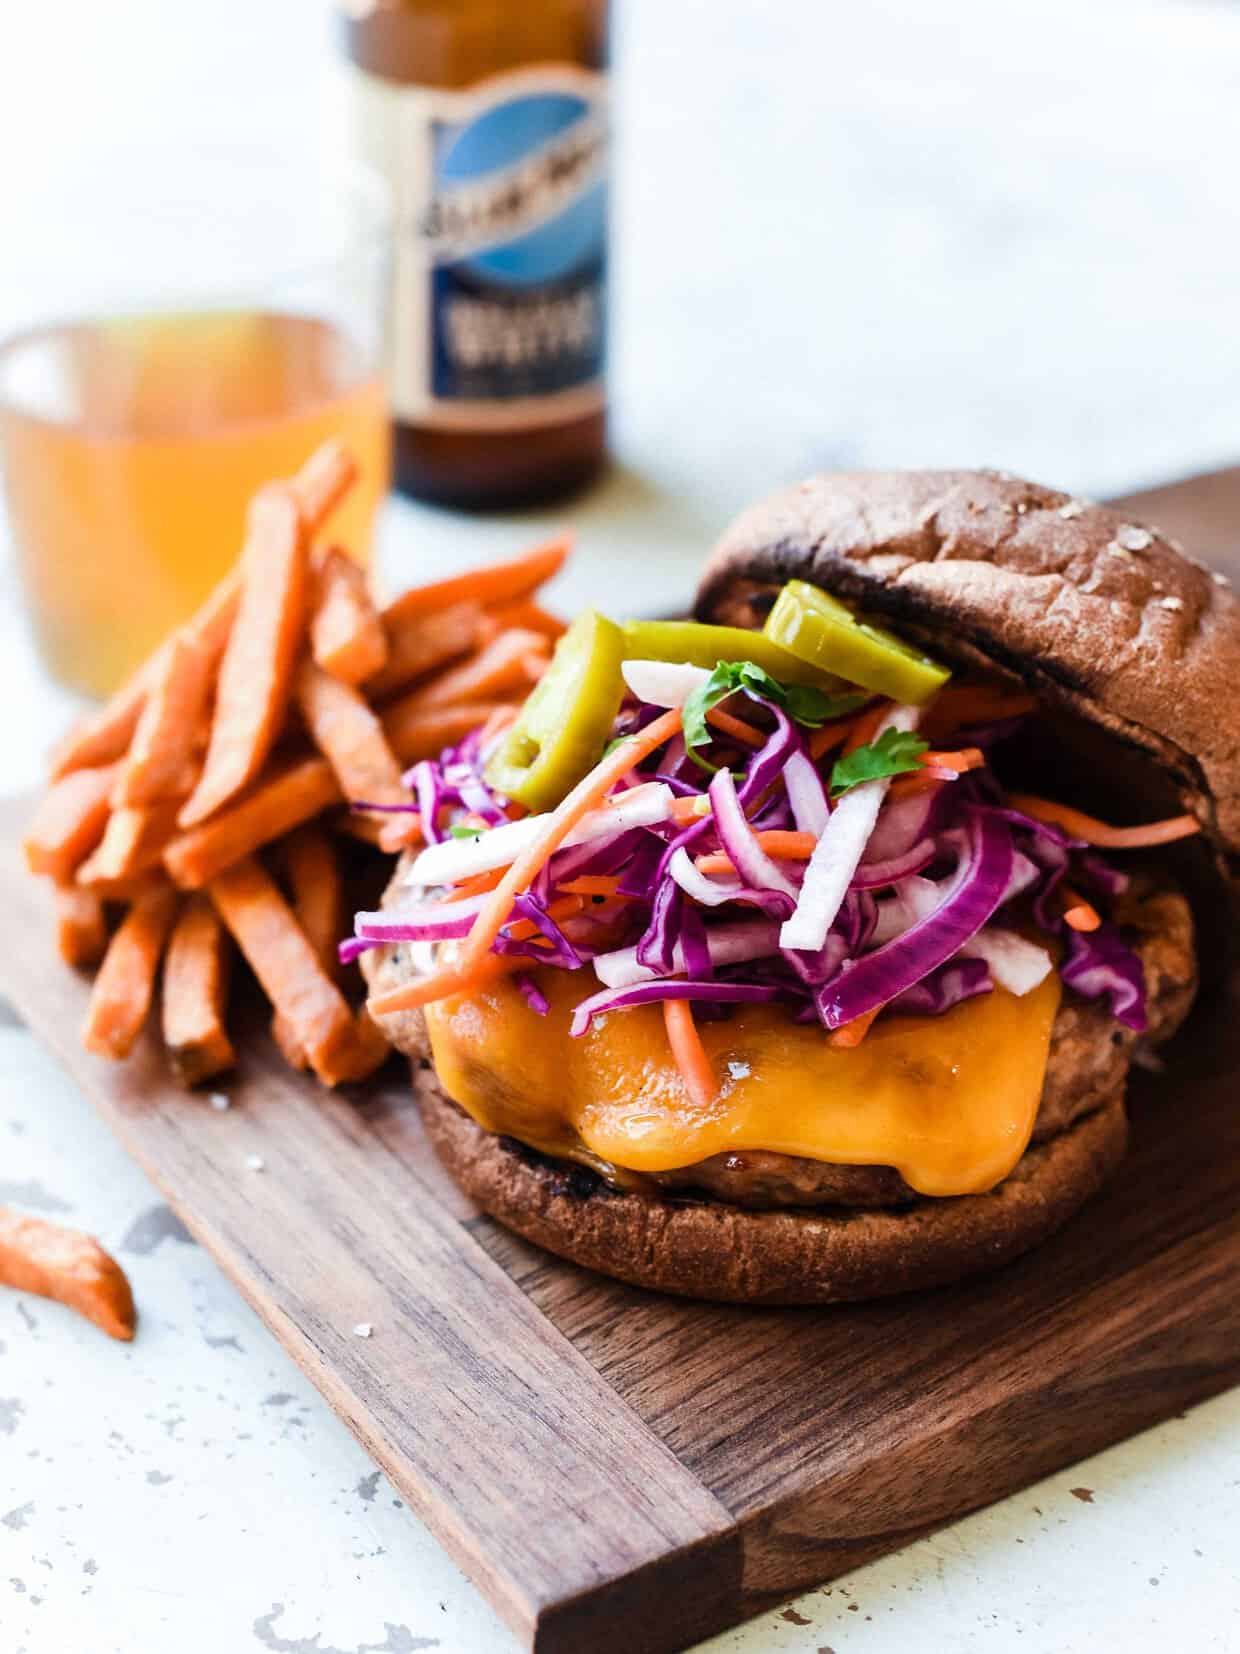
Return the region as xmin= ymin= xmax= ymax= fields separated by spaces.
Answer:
xmin=0 ymin=469 xmax=1240 ymax=1654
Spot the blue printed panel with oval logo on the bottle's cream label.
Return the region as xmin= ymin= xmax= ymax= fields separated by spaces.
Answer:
xmin=418 ymin=74 xmax=607 ymax=416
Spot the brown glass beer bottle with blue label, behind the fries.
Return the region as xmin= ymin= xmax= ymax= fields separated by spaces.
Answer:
xmin=342 ymin=0 xmax=607 ymax=508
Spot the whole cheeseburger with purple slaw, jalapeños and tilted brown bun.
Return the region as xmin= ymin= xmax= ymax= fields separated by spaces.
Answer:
xmin=352 ymin=471 xmax=1240 ymax=1303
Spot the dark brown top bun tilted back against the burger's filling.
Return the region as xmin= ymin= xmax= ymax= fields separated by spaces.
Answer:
xmin=696 ymin=471 xmax=1240 ymax=852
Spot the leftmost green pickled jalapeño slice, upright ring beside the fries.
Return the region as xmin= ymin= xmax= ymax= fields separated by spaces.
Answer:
xmin=486 ymin=609 xmax=625 ymax=810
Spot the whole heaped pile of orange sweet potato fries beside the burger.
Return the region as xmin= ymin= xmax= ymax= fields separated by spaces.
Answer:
xmin=25 ymin=443 xmax=567 ymax=1085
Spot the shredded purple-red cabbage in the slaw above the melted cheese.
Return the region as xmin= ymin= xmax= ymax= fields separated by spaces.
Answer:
xmin=350 ymin=668 xmax=1146 ymax=1034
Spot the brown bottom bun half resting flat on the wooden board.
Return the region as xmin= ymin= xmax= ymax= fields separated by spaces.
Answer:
xmin=413 ymin=1068 xmax=1128 ymax=1303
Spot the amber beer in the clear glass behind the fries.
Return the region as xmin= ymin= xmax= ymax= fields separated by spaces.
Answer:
xmin=0 ymin=311 xmax=390 ymax=695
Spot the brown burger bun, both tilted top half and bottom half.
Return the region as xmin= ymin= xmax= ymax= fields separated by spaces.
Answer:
xmin=383 ymin=471 xmax=1240 ymax=1303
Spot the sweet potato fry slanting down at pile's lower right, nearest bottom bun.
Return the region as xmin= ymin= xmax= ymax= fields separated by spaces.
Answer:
xmin=208 ymin=860 xmax=354 ymax=1085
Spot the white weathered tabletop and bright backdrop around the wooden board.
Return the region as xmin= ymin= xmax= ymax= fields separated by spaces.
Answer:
xmin=0 ymin=0 xmax=1240 ymax=1654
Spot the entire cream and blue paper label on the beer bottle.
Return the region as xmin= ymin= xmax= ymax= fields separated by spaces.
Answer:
xmin=359 ymin=65 xmax=608 ymax=430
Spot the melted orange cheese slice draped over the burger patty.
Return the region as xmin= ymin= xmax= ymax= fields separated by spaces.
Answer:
xmin=427 ymin=969 xmax=1060 ymax=1196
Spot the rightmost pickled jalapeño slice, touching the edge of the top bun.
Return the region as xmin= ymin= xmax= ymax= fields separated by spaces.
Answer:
xmin=762 ymin=581 xmax=951 ymax=706
